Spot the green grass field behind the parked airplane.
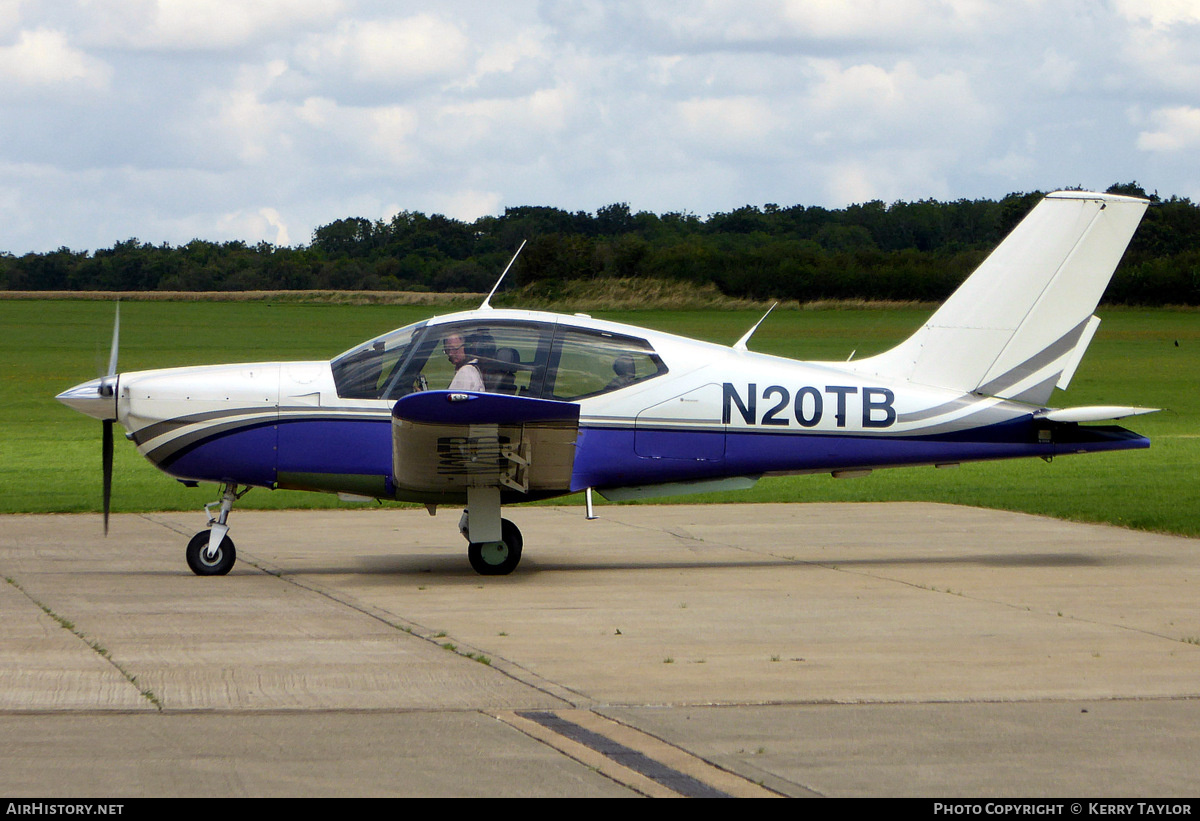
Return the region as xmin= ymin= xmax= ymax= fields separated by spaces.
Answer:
xmin=0 ymin=300 xmax=1200 ymax=537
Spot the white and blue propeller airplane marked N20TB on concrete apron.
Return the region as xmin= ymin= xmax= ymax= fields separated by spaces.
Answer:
xmin=58 ymin=191 xmax=1152 ymax=575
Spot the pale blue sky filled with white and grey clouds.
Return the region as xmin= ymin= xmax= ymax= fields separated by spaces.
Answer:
xmin=0 ymin=0 xmax=1200 ymax=254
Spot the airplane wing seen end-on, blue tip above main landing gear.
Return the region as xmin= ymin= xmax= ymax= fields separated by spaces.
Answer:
xmin=391 ymin=390 xmax=580 ymax=504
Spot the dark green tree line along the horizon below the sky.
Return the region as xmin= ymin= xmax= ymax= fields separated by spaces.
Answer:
xmin=0 ymin=182 xmax=1200 ymax=305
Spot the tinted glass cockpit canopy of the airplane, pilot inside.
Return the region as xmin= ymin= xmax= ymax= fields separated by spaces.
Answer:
xmin=332 ymin=317 xmax=667 ymax=401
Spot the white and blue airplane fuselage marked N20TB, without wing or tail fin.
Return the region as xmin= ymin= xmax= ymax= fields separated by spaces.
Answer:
xmin=60 ymin=310 xmax=1148 ymax=502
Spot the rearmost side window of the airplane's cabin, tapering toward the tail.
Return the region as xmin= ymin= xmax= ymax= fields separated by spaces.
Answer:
xmin=545 ymin=328 xmax=667 ymax=401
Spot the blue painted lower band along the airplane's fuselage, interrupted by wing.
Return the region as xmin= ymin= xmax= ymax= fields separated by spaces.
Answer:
xmin=152 ymin=419 xmax=1150 ymax=492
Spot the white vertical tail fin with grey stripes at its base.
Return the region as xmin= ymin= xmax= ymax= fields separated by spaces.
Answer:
xmin=854 ymin=191 xmax=1148 ymax=404
